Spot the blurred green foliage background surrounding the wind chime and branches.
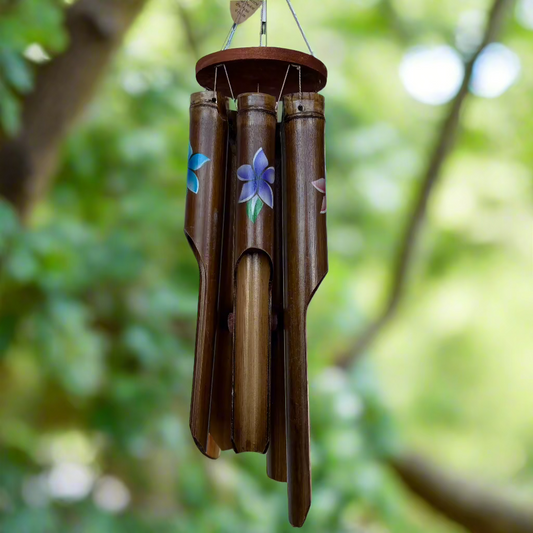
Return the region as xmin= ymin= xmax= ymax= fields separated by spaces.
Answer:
xmin=0 ymin=0 xmax=533 ymax=533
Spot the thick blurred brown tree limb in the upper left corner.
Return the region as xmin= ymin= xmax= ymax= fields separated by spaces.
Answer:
xmin=0 ymin=0 xmax=146 ymax=216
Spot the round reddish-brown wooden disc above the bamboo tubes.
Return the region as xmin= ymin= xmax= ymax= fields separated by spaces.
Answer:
xmin=196 ymin=46 xmax=328 ymax=98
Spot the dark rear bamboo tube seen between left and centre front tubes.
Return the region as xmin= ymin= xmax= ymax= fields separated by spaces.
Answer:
xmin=210 ymin=110 xmax=237 ymax=450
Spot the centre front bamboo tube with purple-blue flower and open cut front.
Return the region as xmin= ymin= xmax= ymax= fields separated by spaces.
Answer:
xmin=232 ymin=93 xmax=277 ymax=453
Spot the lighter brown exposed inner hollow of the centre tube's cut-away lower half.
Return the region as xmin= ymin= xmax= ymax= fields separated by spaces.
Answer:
xmin=233 ymin=252 xmax=271 ymax=453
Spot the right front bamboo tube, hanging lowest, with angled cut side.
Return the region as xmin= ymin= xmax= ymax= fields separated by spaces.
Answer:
xmin=284 ymin=93 xmax=328 ymax=527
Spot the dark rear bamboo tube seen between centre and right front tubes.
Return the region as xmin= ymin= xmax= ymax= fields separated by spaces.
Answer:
xmin=267 ymin=124 xmax=287 ymax=482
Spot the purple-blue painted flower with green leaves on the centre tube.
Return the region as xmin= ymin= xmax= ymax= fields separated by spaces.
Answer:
xmin=237 ymin=148 xmax=276 ymax=223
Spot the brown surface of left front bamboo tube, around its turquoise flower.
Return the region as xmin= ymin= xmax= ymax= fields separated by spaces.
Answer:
xmin=185 ymin=91 xmax=227 ymax=459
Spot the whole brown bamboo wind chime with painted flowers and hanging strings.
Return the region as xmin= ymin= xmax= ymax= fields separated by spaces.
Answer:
xmin=185 ymin=0 xmax=328 ymax=527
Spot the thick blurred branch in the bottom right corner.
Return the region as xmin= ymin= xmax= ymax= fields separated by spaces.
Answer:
xmin=391 ymin=455 xmax=533 ymax=533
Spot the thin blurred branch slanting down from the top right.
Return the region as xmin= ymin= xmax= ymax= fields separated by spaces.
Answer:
xmin=338 ymin=0 xmax=514 ymax=367
